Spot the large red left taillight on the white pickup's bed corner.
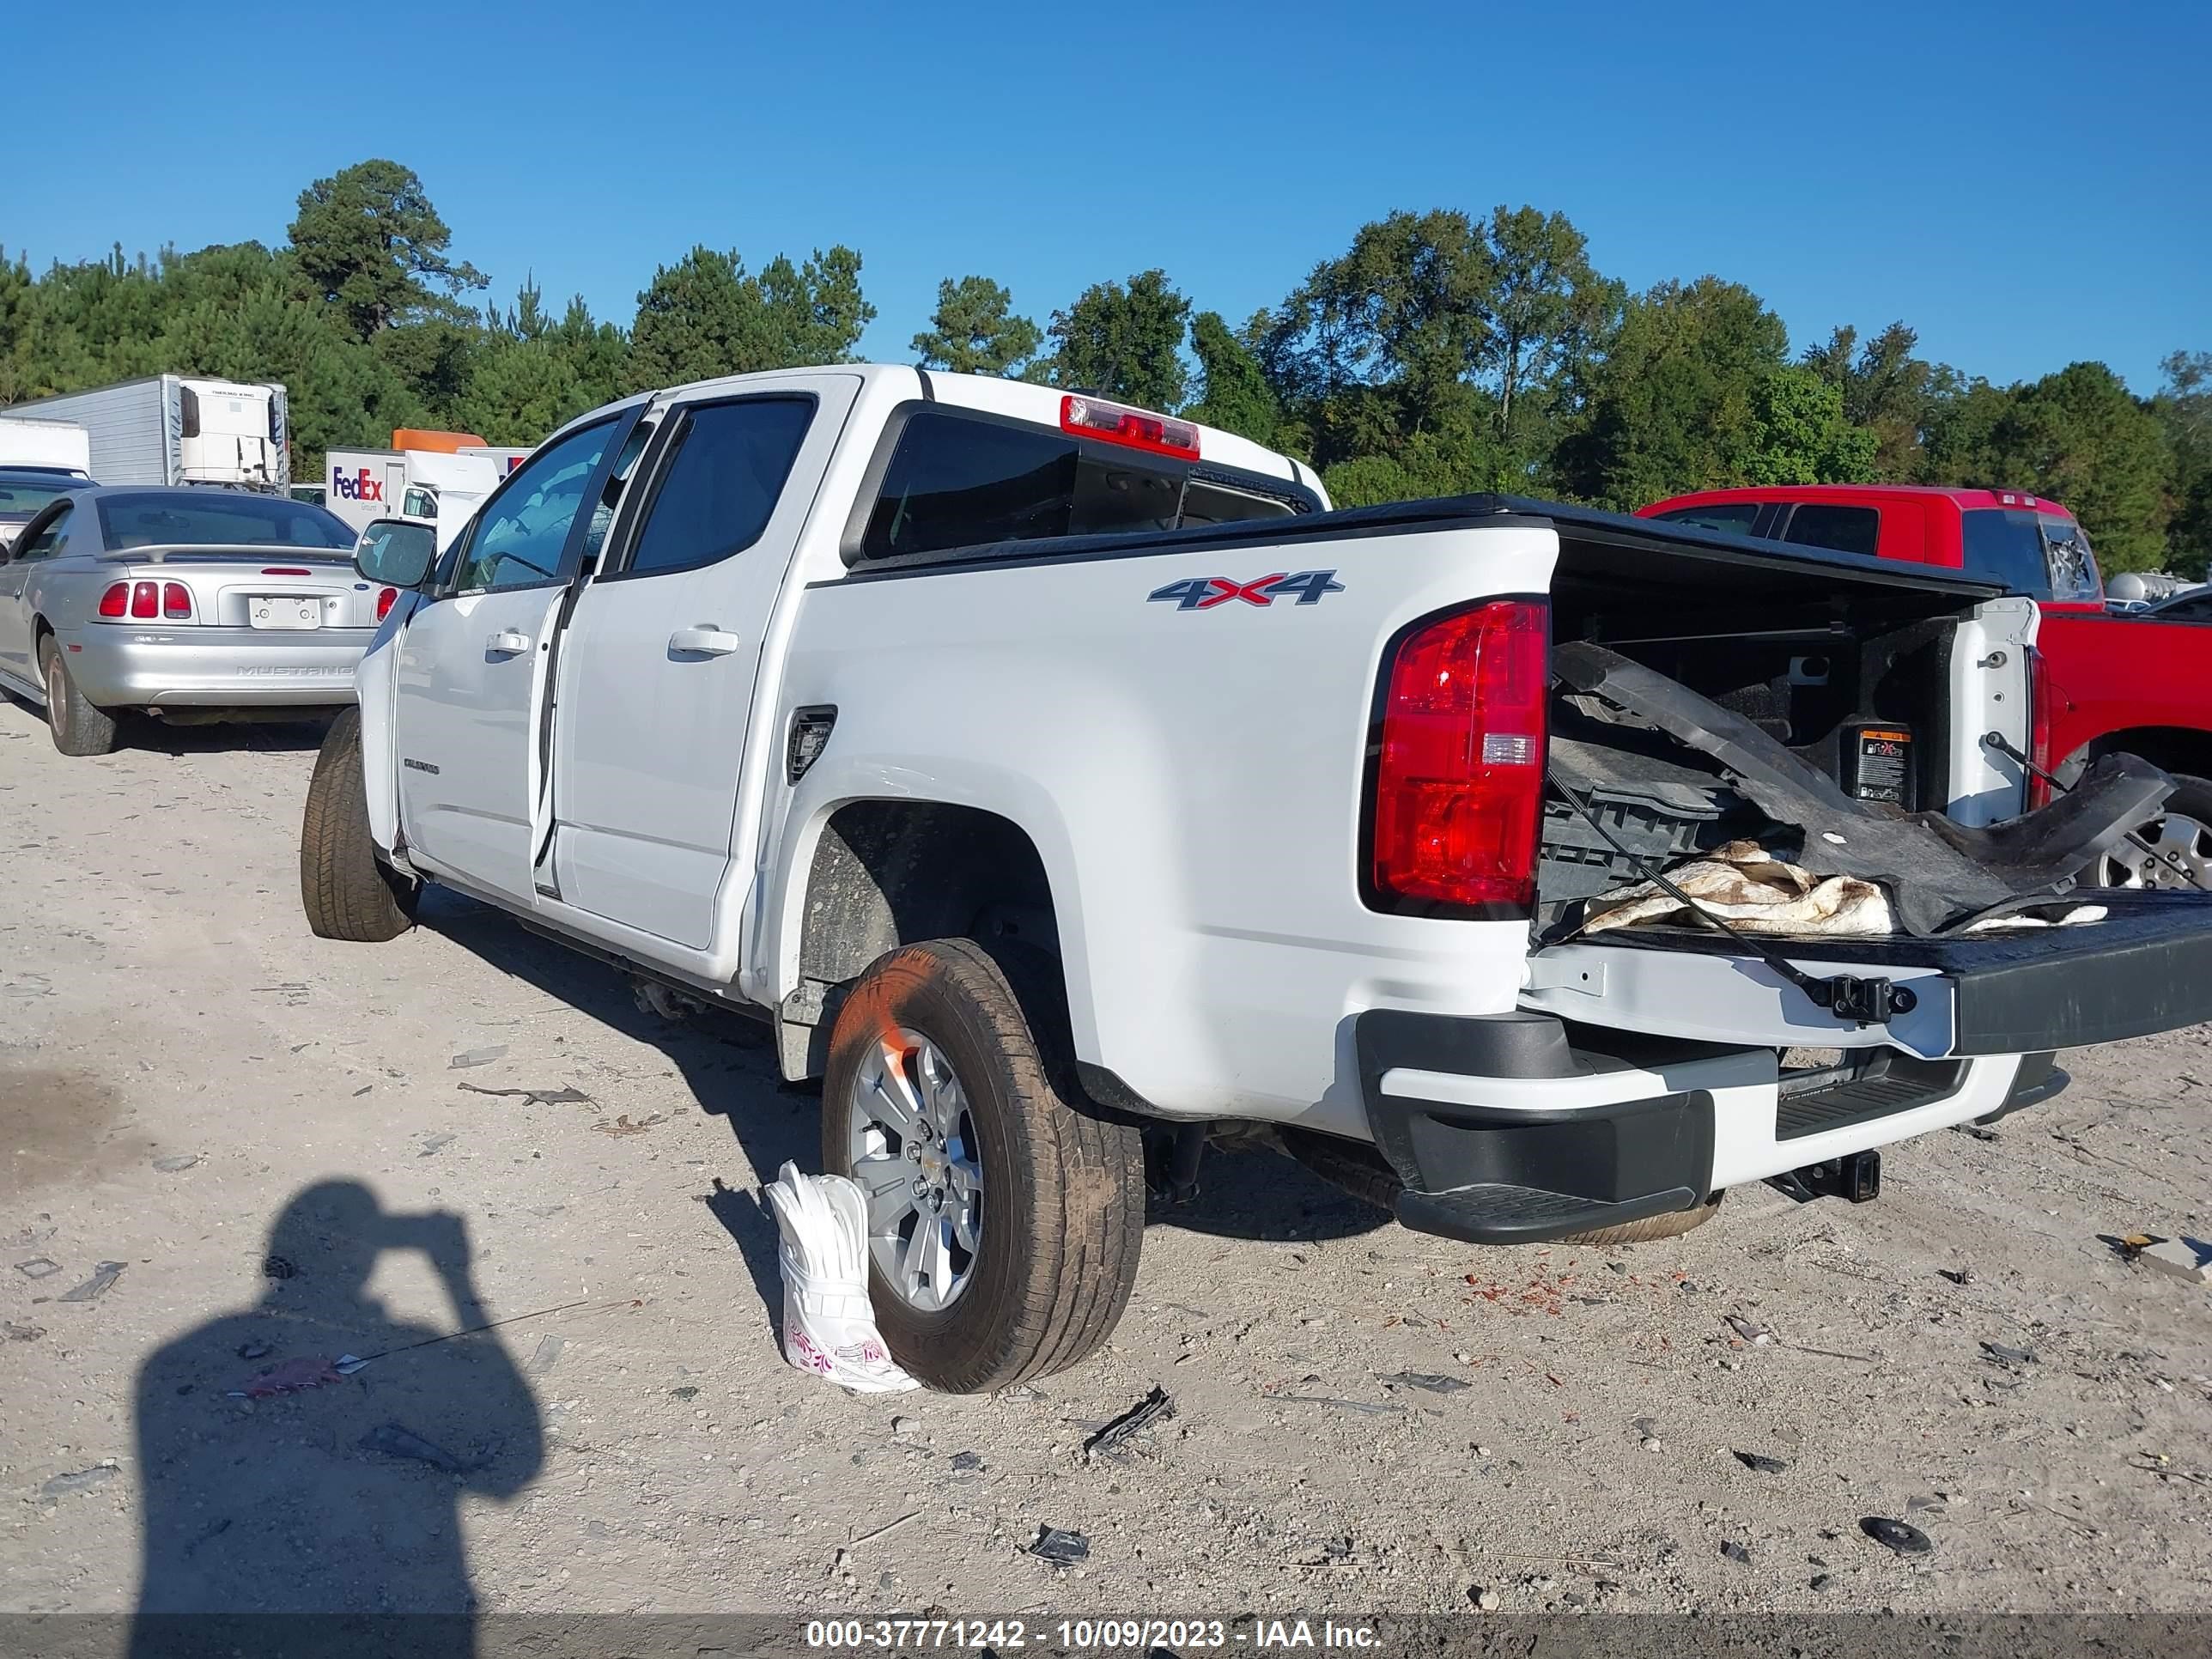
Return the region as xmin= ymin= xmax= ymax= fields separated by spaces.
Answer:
xmin=1370 ymin=599 xmax=1551 ymax=918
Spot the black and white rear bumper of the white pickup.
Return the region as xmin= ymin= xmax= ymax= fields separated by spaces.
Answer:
xmin=1354 ymin=1011 xmax=2051 ymax=1243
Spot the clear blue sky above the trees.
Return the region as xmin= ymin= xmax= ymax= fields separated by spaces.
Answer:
xmin=0 ymin=0 xmax=2212 ymax=392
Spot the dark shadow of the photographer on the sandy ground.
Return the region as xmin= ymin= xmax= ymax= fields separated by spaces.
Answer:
xmin=131 ymin=1182 xmax=544 ymax=1656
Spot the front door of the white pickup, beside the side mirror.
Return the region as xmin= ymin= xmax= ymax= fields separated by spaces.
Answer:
xmin=394 ymin=404 xmax=644 ymax=905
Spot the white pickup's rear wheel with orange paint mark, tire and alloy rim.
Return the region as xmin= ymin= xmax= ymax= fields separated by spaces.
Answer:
xmin=823 ymin=938 xmax=1144 ymax=1394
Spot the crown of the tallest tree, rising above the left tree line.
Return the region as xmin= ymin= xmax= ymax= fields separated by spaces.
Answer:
xmin=292 ymin=161 xmax=487 ymax=341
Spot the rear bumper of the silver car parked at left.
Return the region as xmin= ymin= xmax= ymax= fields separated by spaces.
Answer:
xmin=62 ymin=623 xmax=374 ymax=708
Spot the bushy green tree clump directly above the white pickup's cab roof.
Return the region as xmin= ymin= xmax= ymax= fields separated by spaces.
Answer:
xmin=629 ymin=248 xmax=876 ymax=389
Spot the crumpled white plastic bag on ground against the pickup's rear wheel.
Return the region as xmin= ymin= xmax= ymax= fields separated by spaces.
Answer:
xmin=765 ymin=1164 xmax=921 ymax=1394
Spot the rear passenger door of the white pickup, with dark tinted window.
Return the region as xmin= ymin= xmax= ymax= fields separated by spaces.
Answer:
xmin=548 ymin=374 xmax=860 ymax=949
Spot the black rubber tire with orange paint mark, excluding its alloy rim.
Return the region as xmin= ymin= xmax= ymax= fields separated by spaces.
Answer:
xmin=823 ymin=938 xmax=1144 ymax=1394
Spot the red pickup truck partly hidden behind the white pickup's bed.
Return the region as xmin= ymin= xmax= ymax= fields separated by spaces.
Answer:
xmin=1637 ymin=484 xmax=2212 ymax=887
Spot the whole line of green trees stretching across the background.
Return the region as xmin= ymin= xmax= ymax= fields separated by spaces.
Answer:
xmin=0 ymin=159 xmax=2212 ymax=575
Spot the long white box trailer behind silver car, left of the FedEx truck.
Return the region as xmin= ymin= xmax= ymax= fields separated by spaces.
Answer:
xmin=0 ymin=374 xmax=292 ymax=495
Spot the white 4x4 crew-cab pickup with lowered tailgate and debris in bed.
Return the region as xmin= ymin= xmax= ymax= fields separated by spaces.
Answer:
xmin=301 ymin=368 xmax=2212 ymax=1391
